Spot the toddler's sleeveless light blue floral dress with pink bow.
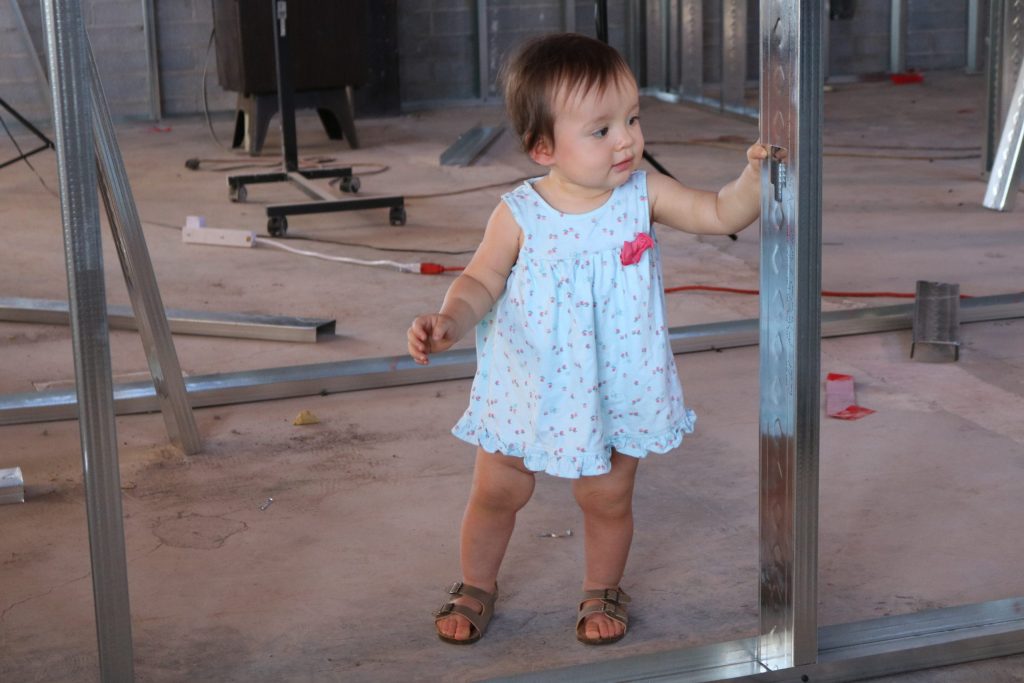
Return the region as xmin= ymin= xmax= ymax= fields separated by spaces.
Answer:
xmin=452 ymin=171 xmax=696 ymax=478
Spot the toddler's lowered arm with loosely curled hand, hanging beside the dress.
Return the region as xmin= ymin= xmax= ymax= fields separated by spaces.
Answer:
xmin=406 ymin=202 xmax=522 ymax=366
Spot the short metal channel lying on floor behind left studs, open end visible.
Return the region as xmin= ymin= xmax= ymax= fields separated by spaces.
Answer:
xmin=0 ymin=297 xmax=336 ymax=343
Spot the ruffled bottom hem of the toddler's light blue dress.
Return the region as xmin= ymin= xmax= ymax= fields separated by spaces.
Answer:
xmin=452 ymin=411 xmax=697 ymax=479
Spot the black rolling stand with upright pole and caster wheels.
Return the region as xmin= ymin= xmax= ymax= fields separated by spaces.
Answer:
xmin=227 ymin=0 xmax=406 ymax=237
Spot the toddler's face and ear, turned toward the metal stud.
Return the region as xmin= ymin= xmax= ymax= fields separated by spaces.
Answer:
xmin=530 ymin=76 xmax=643 ymax=190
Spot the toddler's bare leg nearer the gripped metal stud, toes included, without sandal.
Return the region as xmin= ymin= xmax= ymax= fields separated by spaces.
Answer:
xmin=572 ymin=452 xmax=639 ymax=639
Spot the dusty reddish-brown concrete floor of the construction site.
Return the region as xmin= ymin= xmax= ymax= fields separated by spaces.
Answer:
xmin=0 ymin=74 xmax=1024 ymax=683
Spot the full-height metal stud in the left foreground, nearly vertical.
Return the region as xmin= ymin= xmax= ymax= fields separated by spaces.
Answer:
xmin=43 ymin=0 xmax=134 ymax=681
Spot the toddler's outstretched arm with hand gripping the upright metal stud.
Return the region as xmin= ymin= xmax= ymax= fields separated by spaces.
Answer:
xmin=647 ymin=143 xmax=768 ymax=234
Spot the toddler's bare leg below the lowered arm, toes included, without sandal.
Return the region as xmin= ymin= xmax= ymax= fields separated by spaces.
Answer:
xmin=437 ymin=449 xmax=535 ymax=640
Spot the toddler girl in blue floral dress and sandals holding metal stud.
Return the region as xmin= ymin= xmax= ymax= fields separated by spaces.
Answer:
xmin=408 ymin=34 xmax=766 ymax=645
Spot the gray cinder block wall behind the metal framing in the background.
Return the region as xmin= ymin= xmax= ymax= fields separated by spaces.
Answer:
xmin=0 ymin=0 xmax=987 ymax=131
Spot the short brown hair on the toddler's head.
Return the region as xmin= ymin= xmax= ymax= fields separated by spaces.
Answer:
xmin=499 ymin=33 xmax=633 ymax=152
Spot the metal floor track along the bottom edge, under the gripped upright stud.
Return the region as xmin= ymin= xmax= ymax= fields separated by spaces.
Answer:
xmin=490 ymin=598 xmax=1024 ymax=683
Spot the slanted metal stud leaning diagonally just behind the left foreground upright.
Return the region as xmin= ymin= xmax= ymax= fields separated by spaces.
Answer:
xmin=86 ymin=45 xmax=203 ymax=455
